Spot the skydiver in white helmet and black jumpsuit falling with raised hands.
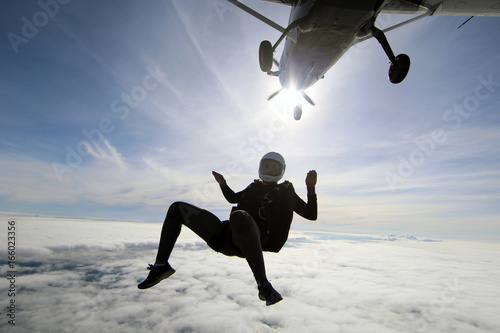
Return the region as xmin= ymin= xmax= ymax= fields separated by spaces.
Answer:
xmin=138 ymin=152 xmax=318 ymax=305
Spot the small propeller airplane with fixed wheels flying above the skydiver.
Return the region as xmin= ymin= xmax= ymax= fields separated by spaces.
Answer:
xmin=227 ymin=0 xmax=500 ymax=120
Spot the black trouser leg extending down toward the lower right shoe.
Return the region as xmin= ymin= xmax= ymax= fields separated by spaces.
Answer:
xmin=229 ymin=210 xmax=267 ymax=283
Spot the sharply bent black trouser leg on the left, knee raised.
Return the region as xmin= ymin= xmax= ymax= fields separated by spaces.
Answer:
xmin=156 ymin=202 xmax=221 ymax=264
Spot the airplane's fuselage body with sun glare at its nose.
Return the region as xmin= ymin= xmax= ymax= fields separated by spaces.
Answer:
xmin=279 ymin=0 xmax=383 ymax=91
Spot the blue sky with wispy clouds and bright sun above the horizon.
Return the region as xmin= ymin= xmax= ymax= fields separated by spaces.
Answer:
xmin=0 ymin=0 xmax=500 ymax=241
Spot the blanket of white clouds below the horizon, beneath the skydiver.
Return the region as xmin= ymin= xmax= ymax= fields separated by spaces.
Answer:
xmin=0 ymin=216 xmax=500 ymax=333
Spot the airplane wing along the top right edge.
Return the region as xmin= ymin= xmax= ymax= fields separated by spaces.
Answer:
xmin=382 ymin=0 xmax=500 ymax=16
